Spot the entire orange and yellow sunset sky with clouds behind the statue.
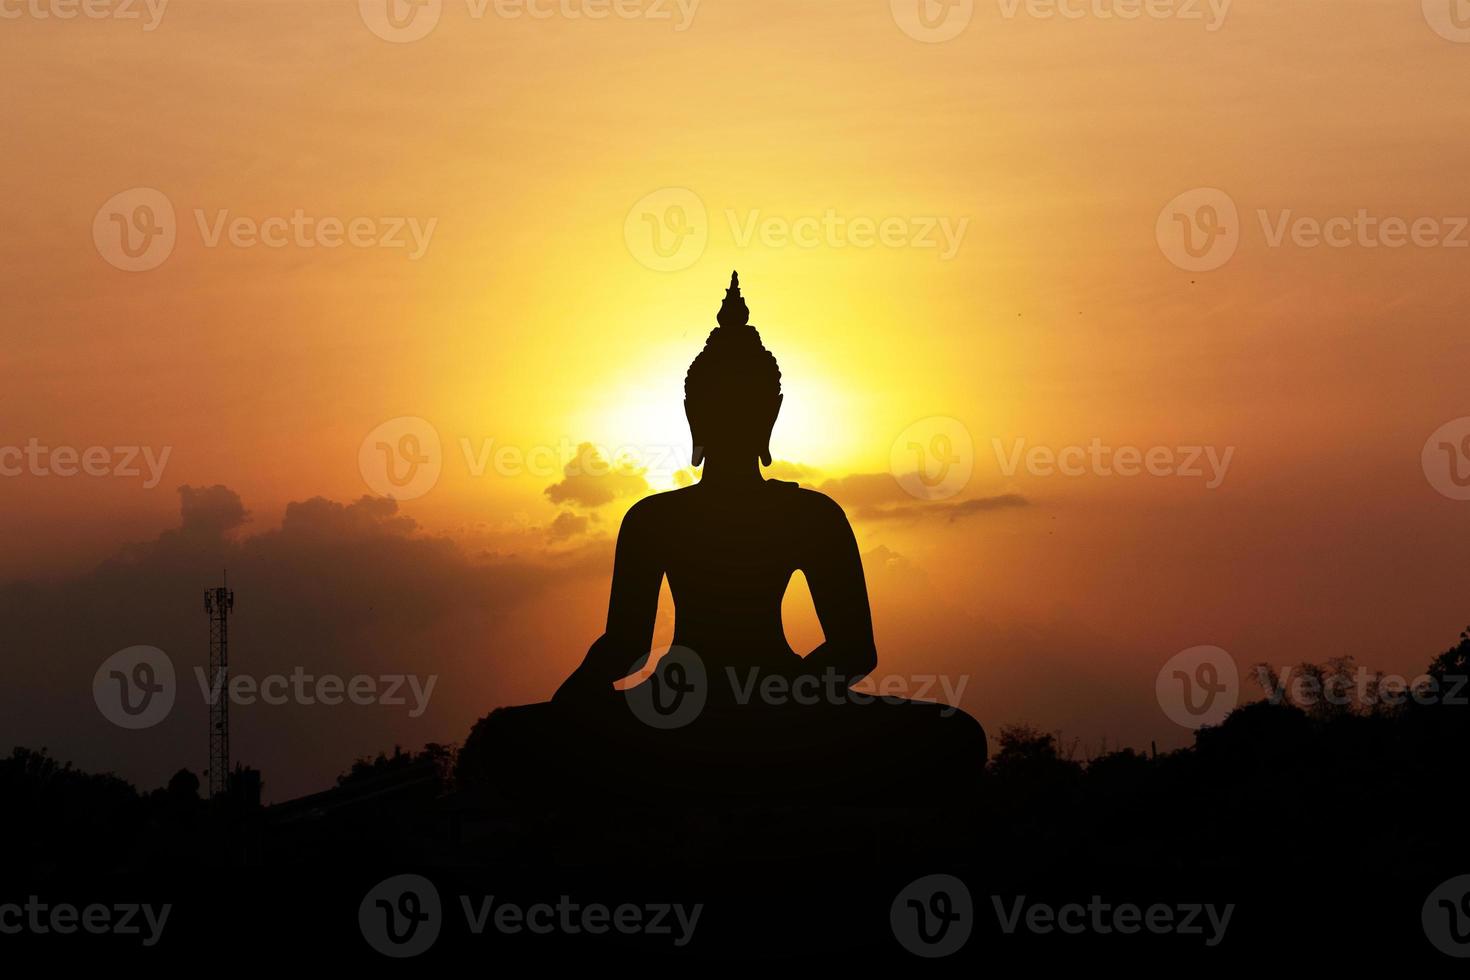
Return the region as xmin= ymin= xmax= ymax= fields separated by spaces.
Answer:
xmin=0 ymin=0 xmax=1470 ymax=799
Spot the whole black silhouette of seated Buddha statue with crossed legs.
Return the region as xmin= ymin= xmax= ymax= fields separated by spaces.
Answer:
xmin=466 ymin=275 xmax=986 ymax=801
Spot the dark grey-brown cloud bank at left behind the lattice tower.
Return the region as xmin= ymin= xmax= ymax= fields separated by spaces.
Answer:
xmin=0 ymin=486 xmax=612 ymax=799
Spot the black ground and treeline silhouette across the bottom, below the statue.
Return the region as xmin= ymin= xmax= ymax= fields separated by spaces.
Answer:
xmin=0 ymin=644 xmax=1470 ymax=976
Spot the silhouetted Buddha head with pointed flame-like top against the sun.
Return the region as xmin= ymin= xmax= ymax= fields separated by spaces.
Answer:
xmin=684 ymin=273 xmax=781 ymax=466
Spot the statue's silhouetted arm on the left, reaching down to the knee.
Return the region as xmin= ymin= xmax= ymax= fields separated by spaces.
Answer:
xmin=554 ymin=501 xmax=663 ymax=701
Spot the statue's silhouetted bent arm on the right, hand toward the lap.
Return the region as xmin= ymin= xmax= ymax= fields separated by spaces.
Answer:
xmin=801 ymin=497 xmax=878 ymax=686
